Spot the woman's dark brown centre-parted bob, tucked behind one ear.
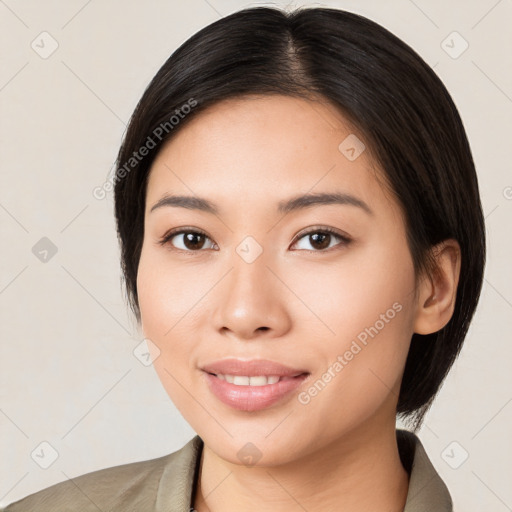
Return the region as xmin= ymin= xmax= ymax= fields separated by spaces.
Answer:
xmin=115 ymin=7 xmax=485 ymax=429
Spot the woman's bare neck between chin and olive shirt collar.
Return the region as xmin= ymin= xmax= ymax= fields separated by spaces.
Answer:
xmin=194 ymin=423 xmax=409 ymax=512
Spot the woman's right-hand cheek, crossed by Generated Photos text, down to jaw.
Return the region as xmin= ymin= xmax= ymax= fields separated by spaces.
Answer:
xmin=294 ymin=245 xmax=414 ymax=425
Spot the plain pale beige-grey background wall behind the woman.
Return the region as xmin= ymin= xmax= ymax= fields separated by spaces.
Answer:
xmin=0 ymin=0 xmax=512 ymax=512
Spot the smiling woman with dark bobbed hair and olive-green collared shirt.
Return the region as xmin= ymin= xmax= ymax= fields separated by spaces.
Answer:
xmin=5 ymin=8 xmax=485 ymax=512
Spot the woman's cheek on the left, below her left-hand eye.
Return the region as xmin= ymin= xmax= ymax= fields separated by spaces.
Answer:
xmin=137 ymin=248 xmax=219 ymax=402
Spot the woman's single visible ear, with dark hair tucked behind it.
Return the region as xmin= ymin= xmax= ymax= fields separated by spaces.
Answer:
xmin=414 ymin=239 xmax=461 ymax=334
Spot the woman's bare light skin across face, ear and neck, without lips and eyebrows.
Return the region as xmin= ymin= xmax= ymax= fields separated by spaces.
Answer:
xmin=137 ymin=95 xmax=460 ymax=512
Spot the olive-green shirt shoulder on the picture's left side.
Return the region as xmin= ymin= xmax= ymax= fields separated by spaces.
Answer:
xmin=0 ymin=436 xmax=202 ymax=512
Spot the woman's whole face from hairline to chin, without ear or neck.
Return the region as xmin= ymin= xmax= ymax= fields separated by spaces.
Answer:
xmin=137 ymin=95 xmax=417 ymax=465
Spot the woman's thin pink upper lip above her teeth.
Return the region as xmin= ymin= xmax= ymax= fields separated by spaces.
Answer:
xmin=202 ymin=359 xmax=309 ymax=377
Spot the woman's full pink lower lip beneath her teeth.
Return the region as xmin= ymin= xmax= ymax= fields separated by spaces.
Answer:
xmin=205 ymin=372 xmax=308 ymax=411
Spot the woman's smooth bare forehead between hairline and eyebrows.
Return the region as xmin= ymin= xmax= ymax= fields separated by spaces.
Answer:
xmin=147 ymin=95 xmax=394 ymax=216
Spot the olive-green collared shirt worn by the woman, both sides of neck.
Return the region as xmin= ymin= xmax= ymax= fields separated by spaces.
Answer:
xmin=2 ymin=430 xmax=453 ymax=512
